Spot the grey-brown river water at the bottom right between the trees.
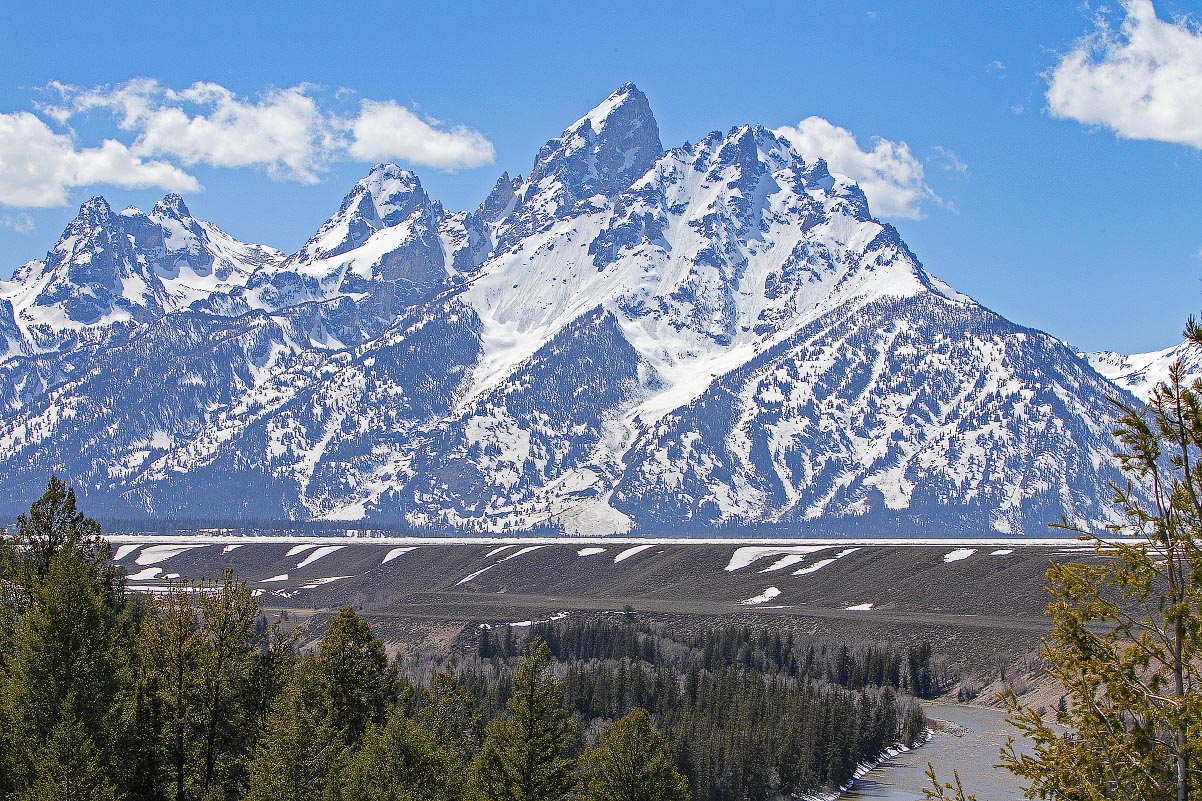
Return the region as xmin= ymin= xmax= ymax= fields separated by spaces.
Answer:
xmin=843 ymin=704 xmax=1023 ymax=801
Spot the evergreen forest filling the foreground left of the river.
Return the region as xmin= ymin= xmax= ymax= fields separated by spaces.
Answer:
xmin=0 ymin=479 xmax=926 ymax=801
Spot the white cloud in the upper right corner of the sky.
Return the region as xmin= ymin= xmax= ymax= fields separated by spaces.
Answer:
xmin=1047 ymin=0 xmax=1202 ymax=148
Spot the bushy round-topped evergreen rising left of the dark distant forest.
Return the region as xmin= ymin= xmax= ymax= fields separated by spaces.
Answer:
xmin=315 ymin=606 xmax=397 ymax=744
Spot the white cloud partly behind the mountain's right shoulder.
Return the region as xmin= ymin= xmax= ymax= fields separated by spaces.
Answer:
xmin=776 ymin=117 xmax=942 ymax=219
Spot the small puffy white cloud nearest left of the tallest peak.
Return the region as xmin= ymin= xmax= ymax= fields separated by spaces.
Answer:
xmin=349 ymin=100 xmax=496 ymax=170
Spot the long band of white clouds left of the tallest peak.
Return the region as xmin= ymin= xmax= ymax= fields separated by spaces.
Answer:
xmin=0 ymin=78 xmax=495 ymax=207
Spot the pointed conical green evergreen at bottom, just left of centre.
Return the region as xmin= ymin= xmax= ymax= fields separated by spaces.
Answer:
xmin=470 ymin=637 xmax=579 ymax=801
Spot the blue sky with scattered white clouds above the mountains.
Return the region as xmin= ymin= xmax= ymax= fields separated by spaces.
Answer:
xmin=0 ymin=0 xmax=1202 ymax=351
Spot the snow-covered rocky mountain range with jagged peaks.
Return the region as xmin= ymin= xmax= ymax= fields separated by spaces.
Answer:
xmin=0 ymin=84 xmax=1163 ymax=534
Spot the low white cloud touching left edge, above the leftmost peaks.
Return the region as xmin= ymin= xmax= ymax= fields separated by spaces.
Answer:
xmin=0 ymin=112 xmax=201 ymax=207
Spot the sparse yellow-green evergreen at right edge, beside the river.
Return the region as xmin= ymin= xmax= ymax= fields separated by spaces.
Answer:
xmin=1002 ymin=348 xmax=1202 ymax=801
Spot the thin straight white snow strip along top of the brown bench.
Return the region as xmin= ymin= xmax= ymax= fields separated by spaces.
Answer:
xmin=103 ymin=534 xmax=1105 ymax=551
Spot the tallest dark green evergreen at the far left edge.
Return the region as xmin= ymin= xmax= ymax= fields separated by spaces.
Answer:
xmin=0 ymin=476 xmax=127 ymax=797
